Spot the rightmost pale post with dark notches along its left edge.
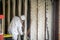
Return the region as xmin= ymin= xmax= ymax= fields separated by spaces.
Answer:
xmin=45 ymin=0 xmax=53 ymax=40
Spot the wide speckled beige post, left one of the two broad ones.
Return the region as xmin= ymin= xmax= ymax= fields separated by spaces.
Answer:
xmin=30 ymin=0 xmax=38 ymax=40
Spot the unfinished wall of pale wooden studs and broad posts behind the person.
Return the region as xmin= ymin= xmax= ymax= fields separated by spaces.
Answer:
xmin=2 ymin=0 xmax=55 ymax=40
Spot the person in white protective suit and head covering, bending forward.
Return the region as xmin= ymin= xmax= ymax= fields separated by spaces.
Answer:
xmin=8 ymin=15 xmax=25 ymax=40
